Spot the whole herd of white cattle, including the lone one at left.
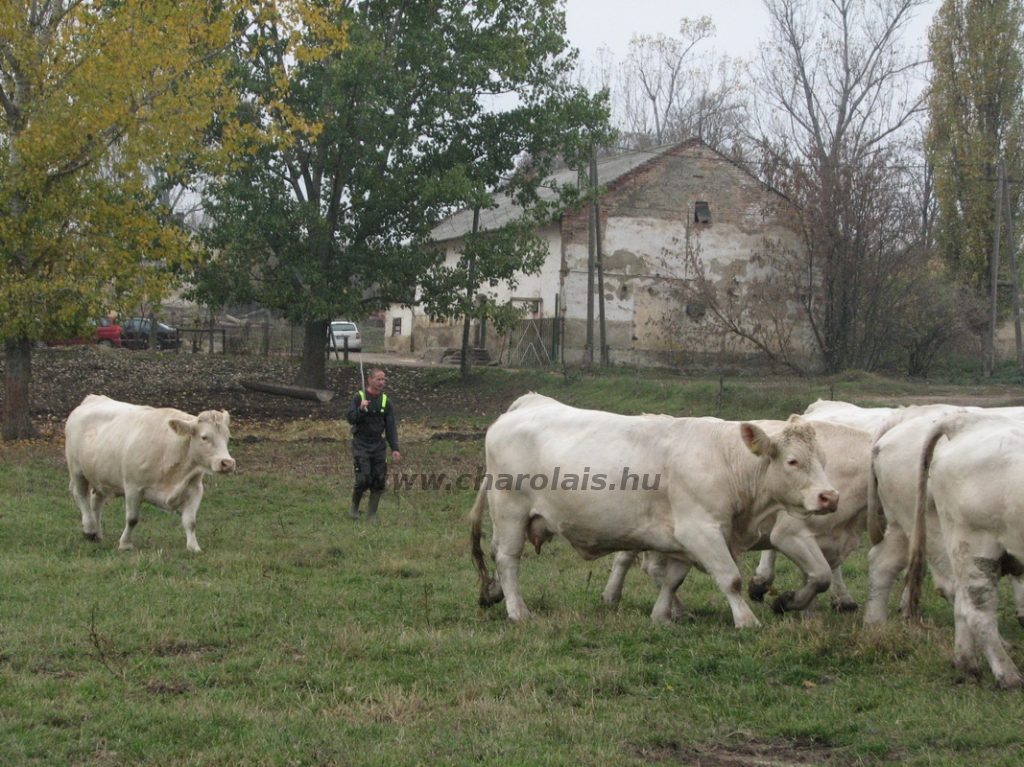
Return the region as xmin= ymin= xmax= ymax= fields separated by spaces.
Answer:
xmin=65 ymin=393 xmax=1024 ymax=688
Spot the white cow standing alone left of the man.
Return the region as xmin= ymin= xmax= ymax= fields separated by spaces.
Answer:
xmin=65 ymin=394 xmax=234 ymax=551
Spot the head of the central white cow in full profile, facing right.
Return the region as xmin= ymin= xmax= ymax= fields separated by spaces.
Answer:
xmin=739 ymin=416 xmax=839 ymax=516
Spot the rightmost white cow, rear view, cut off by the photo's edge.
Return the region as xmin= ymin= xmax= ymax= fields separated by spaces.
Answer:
xmin=907 ymin=413 xmax=1024 ymax=688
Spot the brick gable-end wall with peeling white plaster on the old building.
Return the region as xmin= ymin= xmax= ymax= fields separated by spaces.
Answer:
xmin=562 ymin=143 xmax=799 ymax=364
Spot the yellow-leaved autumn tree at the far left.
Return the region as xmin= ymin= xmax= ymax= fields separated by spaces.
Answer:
xmin=0 ymin=0 xmax=250 ymax=440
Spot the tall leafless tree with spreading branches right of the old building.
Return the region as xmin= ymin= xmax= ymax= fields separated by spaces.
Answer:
xmin=757 ymin=0 xmax=937 ymax=371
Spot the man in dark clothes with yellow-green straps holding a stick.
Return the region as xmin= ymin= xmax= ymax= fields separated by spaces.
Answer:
xmin=346 ymin=368 xmax=401 ymax=521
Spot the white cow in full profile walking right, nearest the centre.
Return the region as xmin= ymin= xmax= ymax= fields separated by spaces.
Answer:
xmin=470 ymin=394 xmax=839 ymax=627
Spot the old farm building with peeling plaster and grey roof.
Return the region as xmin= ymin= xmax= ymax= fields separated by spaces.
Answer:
xmin=385 ymin=139 xmax=808 ymax=365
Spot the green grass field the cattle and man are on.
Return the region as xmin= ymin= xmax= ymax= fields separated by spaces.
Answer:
xmin=0 ymin=371 xmax=1024 ymax=767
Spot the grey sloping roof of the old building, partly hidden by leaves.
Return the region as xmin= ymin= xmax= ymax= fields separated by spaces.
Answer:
xmin=430 ymin=141 xmax=692 ymax=242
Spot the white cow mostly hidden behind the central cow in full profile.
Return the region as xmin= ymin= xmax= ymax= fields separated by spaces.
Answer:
xmin=602 ymin=419 xmax=872 ymax=617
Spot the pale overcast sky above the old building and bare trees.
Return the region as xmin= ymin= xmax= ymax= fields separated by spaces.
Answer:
xmin=565 ymin=0 xmax=941 ymax=66
